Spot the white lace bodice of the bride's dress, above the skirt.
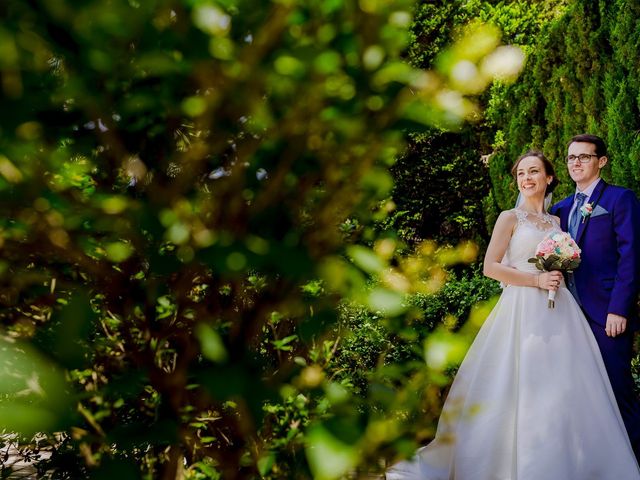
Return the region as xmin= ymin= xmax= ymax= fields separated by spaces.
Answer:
xmin=501 ymin=208 xmax=561 ymax=272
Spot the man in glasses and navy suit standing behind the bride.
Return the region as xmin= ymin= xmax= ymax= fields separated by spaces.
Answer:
xmin=550 ymin=134 xmax=640 ymax=459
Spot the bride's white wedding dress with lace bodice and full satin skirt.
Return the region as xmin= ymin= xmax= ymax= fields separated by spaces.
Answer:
xmin=386 ymin=209 xmax=640 ymax=480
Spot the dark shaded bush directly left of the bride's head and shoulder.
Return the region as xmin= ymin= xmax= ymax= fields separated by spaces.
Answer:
xmin=385 ymin=127 xmax=490 ymax=245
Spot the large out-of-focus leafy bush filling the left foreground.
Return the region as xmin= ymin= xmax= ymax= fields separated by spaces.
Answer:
xmin=0 ymin=0 xmax=517 ymax=479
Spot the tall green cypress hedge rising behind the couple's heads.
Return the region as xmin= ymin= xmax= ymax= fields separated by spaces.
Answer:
xmin=487 ymin=0 xmax=640 ymax=208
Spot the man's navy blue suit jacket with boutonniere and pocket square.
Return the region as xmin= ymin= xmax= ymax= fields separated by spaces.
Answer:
xmin=550 ymin=180 xmax=640 ymax=330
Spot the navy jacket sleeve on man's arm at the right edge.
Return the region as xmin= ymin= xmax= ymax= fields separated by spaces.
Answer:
xmin=608 ymin=190 xmax=640 ymax=318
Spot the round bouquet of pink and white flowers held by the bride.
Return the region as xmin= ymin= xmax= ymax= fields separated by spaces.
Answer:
xmin=529 ymin=232 xmax=581 ymax=308
